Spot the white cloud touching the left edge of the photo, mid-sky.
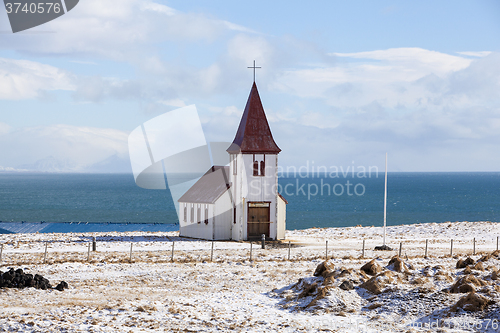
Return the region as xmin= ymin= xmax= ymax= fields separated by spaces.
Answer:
xmin=0 ymin=58 xmax=75 ymax=100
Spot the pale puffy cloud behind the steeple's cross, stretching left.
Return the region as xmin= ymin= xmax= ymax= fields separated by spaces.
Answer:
xmin=129 ymin=34 xmax=280 ymax=99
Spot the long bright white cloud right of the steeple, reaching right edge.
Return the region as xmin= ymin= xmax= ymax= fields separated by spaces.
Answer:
xmin=272 ymin=48 xmax=500 ymax=109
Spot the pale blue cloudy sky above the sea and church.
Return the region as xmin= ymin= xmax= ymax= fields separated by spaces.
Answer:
xmin=0 ymin=0 xmax=500 ymax=171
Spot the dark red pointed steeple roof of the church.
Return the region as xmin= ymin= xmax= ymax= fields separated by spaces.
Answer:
xmin=227 ymin=82 xmax=281 ymax=154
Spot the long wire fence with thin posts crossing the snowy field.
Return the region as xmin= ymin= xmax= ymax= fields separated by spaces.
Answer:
xmin=0 ymin=236 xmax=499 ymax=266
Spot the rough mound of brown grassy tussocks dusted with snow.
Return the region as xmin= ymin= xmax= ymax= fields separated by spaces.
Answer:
xmin=272 ymin=251 xmax=500 ymax=332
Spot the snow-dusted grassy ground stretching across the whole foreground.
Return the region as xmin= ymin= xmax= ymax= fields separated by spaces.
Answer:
xmin=0 ymin=222 xmax=500 ymax=332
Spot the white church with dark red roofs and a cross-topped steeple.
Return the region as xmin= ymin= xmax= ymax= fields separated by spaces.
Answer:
xmin=178 ymin=81 xmax=288 ymax=240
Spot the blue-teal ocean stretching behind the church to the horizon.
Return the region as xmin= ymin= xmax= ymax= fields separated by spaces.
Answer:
xmin=0 ymin=172 xmax=500 ymax=232
